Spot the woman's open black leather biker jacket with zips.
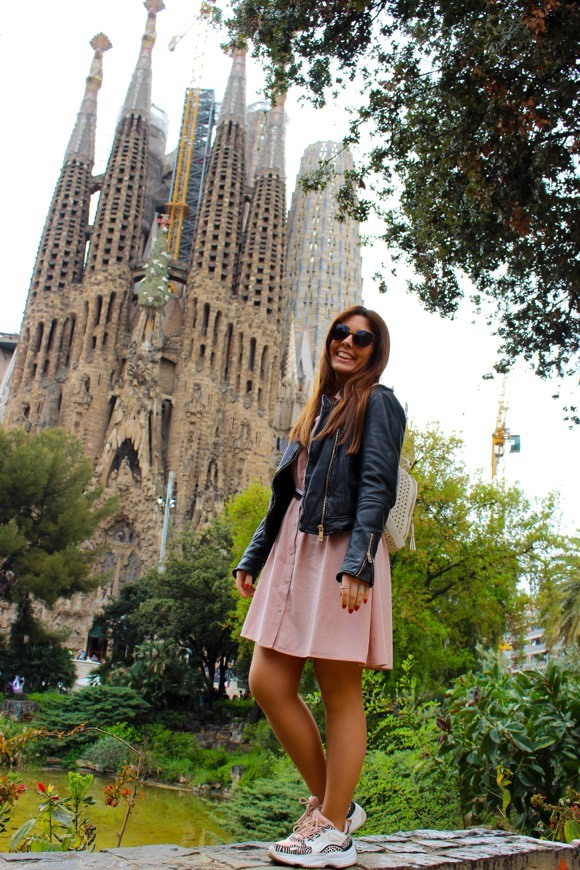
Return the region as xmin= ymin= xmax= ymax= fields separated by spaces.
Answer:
xmin=234 ymin=385 xmax=405 ymax=586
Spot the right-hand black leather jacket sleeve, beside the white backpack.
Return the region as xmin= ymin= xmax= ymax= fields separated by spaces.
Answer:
xmin=336 ymin=386 xmax=406 ymax=586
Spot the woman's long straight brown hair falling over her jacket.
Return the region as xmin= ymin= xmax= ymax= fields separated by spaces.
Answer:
xmin=290 ymin=305 xmax=391 ymax=454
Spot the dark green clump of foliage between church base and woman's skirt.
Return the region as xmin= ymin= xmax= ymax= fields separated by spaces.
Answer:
xmin=102 ymin=518 xmax=237 ymax=709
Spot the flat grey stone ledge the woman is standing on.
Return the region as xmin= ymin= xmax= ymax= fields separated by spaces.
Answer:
xmin=0 ymin=828 xmax=580 ymax=870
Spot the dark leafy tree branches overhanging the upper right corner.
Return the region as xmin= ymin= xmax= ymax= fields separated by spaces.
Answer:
xmin=229 ymin=0 xmax=580 ymax=388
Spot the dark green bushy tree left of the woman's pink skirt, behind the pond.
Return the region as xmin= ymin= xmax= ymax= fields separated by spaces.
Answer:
xmin=102 ymin=518 xmax=237 ymax=705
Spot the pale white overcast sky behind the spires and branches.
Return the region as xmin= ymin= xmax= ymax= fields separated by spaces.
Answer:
xmin=0 ymin=0 xmax=580 ymax=532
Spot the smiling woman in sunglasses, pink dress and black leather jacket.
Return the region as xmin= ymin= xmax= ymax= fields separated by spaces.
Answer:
xmin=235 ymin=305 xmax=405 ymax=867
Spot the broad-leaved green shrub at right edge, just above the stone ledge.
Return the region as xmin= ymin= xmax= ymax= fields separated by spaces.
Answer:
xmin=438 ymin=662 xmax=580 ymax=834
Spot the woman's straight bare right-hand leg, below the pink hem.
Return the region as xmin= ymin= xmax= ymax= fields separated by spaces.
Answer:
xmin=314 ymin=659 xmax=367 ymax=831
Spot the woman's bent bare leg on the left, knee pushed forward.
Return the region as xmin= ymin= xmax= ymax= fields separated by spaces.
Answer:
xmin=249 ymin=644 xmax=328 ymax=800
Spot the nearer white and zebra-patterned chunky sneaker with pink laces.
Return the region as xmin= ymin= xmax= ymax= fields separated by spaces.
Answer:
xmin=268 ymin=809 xmax=356 ymax=867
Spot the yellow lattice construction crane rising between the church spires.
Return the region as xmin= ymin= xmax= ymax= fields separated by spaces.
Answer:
xmin=165 ymin=0 xmax=222 ymax=260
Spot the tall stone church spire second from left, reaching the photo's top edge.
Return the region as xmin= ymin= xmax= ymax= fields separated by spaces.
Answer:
xmin=87 ymin=0 xmax=165 ymax=272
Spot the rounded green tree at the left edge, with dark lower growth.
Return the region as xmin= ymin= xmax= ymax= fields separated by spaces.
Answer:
xmin=0 ymin=429 xmax=116 ymax=690
